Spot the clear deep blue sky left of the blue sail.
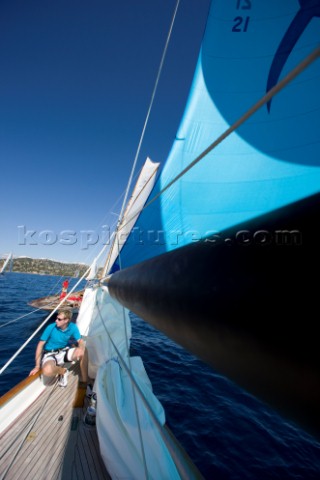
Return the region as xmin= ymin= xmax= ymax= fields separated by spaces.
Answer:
xmin=0 ymin=0 xmax=210 ymax=263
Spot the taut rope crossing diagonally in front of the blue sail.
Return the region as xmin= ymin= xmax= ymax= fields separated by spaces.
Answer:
xmin=101 ymin=47 xmax=320 ymax=255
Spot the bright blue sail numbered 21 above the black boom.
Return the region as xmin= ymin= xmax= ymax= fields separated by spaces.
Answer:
xmin=118 ymin=0 xmax=320 ymax=267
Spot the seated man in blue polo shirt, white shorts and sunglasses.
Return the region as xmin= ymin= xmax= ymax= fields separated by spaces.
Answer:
xmin=30 ymin=310 xmax=88 ymax=387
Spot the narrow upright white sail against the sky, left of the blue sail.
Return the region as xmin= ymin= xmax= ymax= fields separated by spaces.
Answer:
xmin=103 ymin=157 xmax=160 ymax=276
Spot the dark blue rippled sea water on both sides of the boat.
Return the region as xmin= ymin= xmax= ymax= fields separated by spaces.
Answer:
xmin=0 ymin=273 xmax=320 ymax=480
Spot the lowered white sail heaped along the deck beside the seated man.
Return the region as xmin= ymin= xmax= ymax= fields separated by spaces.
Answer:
xmin=77 ymin=286 xmax=180 ymax=480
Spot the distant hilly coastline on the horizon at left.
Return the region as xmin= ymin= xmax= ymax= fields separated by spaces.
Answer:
xmin=0 ymin=257 xmax=88 ymax=277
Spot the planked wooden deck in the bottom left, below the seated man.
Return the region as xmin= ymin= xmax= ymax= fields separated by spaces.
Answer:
xmin=0 ymin=365 xmax=110 ymax=480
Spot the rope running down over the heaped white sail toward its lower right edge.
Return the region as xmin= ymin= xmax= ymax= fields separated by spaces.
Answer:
xmin=97 ymin=304 xmax=194 ymax=479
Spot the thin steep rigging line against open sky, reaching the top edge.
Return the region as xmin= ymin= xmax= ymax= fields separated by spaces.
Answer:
xmin=119 ymin=0 xmax=180 ymax=221
